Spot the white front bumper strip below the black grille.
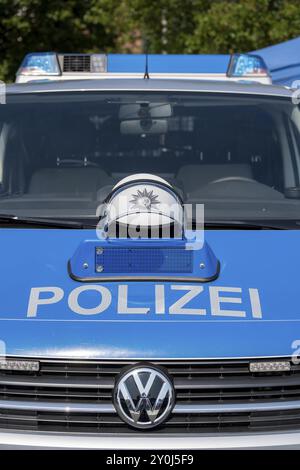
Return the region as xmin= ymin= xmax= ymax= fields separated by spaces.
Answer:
xmin=0 ymin=430 xmax=300 ymax=451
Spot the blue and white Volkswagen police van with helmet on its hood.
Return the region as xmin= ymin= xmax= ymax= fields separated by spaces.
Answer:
xmin=0 ymin=48 xmax=300 ymax=449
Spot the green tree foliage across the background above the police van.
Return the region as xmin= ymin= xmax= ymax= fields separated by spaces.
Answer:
xmin=0 ymin=0 xmax=300 ymax=80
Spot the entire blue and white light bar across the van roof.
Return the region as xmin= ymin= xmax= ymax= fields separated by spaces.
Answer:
xmin=17 ymin=52 xmax=271 ymax=83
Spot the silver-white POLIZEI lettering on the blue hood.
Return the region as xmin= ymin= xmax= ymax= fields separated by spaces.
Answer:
xmin=27 ymin=284 xmax=263 ymax=319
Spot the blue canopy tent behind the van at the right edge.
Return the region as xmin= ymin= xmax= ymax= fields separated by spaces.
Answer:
xmin=252 ymin=37 xmax=300 ymax=86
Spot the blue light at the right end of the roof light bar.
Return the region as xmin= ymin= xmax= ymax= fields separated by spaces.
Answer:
xmin=227 ymin=54 xmax=269 ymax=79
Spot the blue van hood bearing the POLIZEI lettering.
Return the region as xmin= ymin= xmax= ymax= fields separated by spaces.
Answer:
xmin=0 ymin=229 xmax=300 ymax=359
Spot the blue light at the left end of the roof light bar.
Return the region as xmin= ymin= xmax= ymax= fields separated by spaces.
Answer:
xmin=18 ymin=52 xmax=61 ymax=76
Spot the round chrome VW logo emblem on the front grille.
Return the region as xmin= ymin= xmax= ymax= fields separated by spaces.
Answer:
xmin=114 ymin=366 xmax=175 ymax=429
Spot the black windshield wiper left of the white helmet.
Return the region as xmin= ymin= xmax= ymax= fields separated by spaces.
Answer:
xmin=0 ymin=214 xmax=95 ymax=229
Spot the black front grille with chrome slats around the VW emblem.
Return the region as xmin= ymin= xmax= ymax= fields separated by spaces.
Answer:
xmin=0 ymin=358 xmax=300 ymax=433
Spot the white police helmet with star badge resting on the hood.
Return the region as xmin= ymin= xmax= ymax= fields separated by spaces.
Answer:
xmin=101 ymin=173 xmax=183 ymax=238
